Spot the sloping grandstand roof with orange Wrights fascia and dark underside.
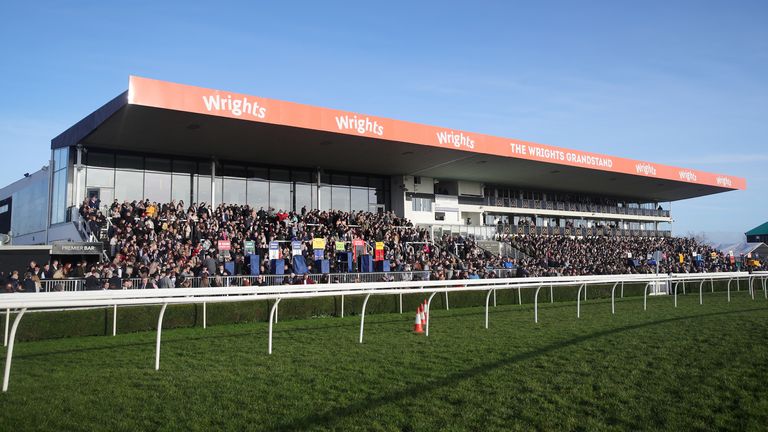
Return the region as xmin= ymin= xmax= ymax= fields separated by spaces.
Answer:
xmin=51 ymin=76 xmax=746 ymax=201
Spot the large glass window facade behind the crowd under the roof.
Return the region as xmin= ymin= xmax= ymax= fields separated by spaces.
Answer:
xmin=82 ymin=150 xmax=389 ymax=211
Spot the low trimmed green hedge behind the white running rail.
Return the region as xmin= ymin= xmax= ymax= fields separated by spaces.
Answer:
xmin=0 ymin=282 xmax=732 ymax=341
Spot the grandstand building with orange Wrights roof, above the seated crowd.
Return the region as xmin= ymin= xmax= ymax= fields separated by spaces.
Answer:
xmin=0 ymin=77 xmax=746 ymax=244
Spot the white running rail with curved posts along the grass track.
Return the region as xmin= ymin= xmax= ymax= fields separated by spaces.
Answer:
xmin=0 ymin=272 xmax=768 ymax=392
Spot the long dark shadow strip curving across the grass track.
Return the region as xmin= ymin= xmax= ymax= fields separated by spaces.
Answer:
xmin=276 ymin=308 xmax=765 ymax=431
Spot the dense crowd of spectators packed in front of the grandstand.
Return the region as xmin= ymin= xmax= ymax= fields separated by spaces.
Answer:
xmin=0 ymin=198 xmax=768 ymax=292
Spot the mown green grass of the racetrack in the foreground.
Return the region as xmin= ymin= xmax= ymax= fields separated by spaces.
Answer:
xmin=0 ymin=291 xmax=768 ymax=431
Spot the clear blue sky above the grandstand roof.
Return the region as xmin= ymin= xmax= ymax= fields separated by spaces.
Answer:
xmin=0 ymin=0 xmax=768 ymax=242
